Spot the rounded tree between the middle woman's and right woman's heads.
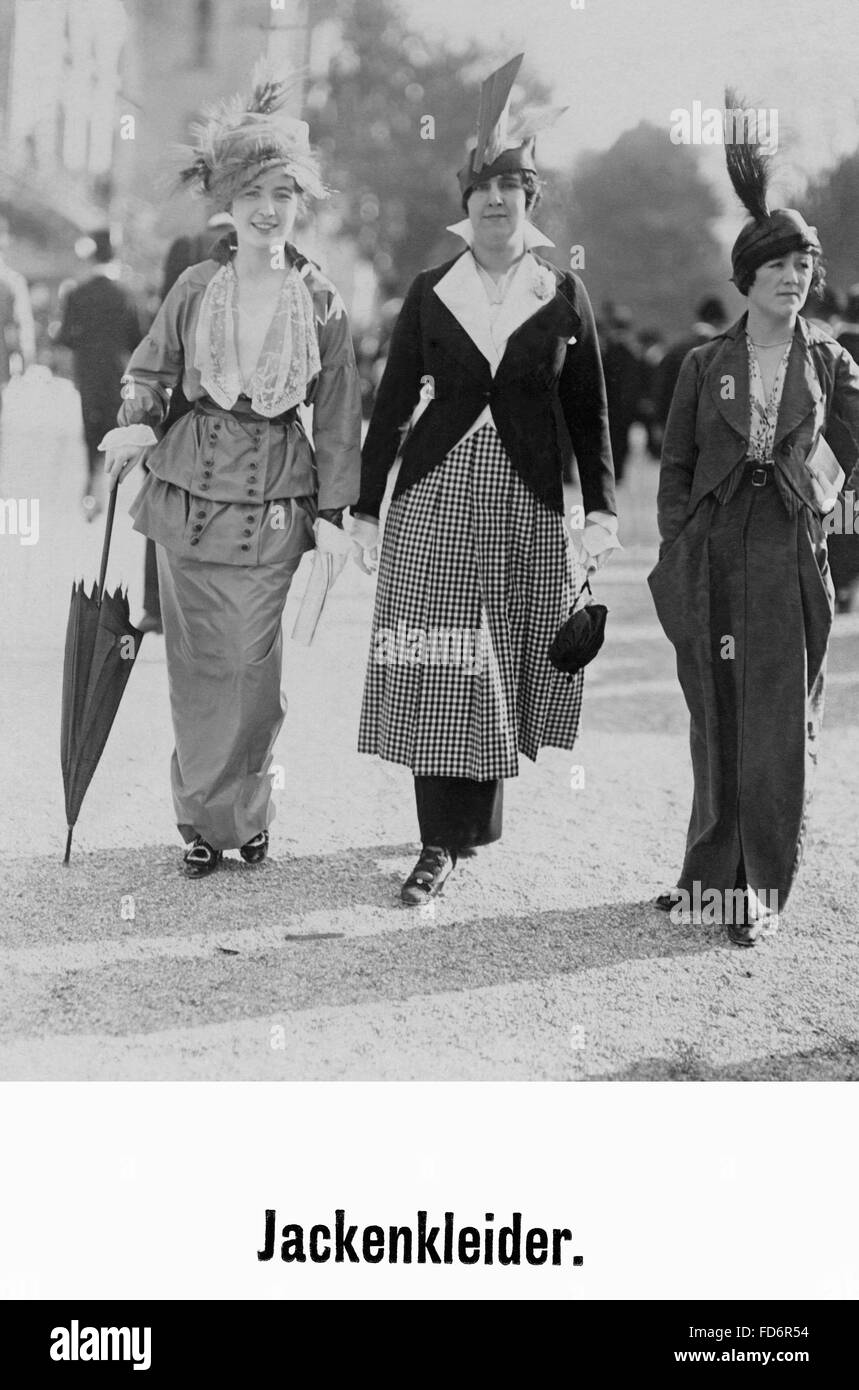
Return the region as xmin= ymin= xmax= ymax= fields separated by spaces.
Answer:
xmin=538 ymin=121 xmax=730 ymax=332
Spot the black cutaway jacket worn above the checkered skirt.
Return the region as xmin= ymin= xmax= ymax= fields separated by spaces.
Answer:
xmin=353 ymin=252 xmax=616 ymax=517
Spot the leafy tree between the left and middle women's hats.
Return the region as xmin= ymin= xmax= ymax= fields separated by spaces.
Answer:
xmin=306 ymin=0 xmax=548 ymax=295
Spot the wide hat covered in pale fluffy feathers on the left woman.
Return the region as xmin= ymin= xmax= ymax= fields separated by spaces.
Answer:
xmin=179 ymin=58 xmax=329 ymax=207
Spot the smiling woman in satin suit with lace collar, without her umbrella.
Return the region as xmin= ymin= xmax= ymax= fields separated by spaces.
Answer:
xmin=108 ymin=67 xmax=360 ymax=877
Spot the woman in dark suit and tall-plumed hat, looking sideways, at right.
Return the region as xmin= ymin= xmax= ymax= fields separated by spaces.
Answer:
xmin=649 ymin=111 xmax=859 ymax=945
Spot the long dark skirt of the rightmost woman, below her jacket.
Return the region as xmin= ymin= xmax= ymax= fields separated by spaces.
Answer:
xmin=649 ymin=474 xmax=833 ymax=910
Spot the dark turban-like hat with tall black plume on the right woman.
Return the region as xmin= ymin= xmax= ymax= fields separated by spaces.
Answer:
xmin=724 ymin=88 xmax=821 ymax=284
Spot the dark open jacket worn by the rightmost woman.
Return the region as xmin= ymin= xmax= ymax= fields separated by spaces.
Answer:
xmin=657 ymin=314 xmax=859 ymax=555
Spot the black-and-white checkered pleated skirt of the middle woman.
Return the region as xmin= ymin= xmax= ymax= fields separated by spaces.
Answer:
xmin=359 ymin=425 xmax=584 ymax=781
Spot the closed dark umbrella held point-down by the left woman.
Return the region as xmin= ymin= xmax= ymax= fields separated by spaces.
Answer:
xmin=60 ymin=488 xmax=143 ymax=865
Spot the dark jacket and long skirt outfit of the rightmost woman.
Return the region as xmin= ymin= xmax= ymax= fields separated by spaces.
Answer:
xmin=649 ymin=316 xmax=859 ymax=908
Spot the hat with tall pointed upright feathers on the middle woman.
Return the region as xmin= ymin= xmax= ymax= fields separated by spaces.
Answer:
xmin=457 ymin=53 xmax=567 ymax=197
